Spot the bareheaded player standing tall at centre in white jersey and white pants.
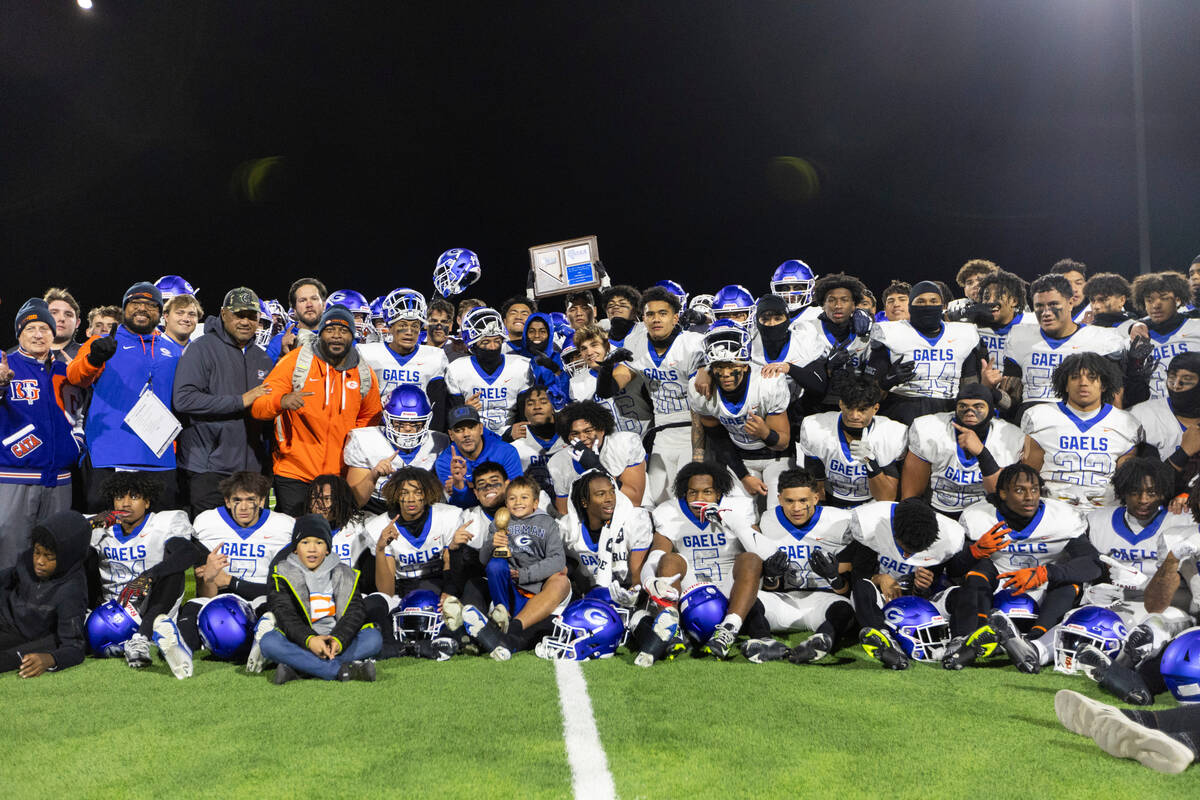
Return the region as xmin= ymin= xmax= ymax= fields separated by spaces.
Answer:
xmin=624 ymin=287 xmax=704 ymax=503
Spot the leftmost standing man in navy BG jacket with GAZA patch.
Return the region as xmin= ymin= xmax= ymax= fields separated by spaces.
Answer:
xmin=0 ymin=297 xmax=80 ymax=570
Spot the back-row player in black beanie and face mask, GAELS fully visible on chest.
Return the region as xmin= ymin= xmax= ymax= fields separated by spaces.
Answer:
xmin=868 ymin=281 xmax=988 ymax=425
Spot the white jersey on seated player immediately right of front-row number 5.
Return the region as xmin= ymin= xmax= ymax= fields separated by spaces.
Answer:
xmin=755 ymin=506 xmax=851 ymax=590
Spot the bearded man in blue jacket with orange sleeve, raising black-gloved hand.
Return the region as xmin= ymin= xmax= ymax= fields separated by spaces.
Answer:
xmin=67 ymin=282 xmax=184 ymax=511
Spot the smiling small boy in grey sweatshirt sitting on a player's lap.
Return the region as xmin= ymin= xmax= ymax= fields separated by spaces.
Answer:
xmin=468 ymin=475 xmax=571 ymax=661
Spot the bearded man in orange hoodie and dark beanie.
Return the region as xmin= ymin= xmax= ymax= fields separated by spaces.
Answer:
xmin=251 ymin=306 xmax=382 ymax=516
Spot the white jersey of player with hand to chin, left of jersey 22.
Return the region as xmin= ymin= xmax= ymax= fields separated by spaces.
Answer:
xmin=908 ymin=411 xmax=1025 ymax=513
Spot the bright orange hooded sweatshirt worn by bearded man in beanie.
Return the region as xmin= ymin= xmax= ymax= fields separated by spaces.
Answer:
xmin=251 ymin=339 xmax=383 ymax=481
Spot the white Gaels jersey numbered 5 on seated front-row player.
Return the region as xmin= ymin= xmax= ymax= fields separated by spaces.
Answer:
xmin=652 ymin=497 xmax=757 ymax=590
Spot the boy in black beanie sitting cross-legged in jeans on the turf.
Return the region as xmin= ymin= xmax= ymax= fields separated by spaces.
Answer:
xmin=260 ymin=513 xmax=383 ymax=684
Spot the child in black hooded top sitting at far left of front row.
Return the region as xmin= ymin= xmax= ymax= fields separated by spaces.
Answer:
xmin=0 ymin=511 xmax=91 ymax=678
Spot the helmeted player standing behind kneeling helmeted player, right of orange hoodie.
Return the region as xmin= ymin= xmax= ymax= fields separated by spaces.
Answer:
xmin=359 ymin=289 xmax=449 ymax=422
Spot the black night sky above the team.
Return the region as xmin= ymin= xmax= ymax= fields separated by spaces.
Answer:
xmin=0 ymin=0 xmax=1200 ymax=328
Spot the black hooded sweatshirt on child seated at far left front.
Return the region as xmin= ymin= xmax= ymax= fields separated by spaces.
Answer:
xmin=0 ymin=511 xmax=91 ymax=669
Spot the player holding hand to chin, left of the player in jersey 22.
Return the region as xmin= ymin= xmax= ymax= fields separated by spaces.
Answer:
xmin=900 ymin=384 xmax=1025 ymax=518
